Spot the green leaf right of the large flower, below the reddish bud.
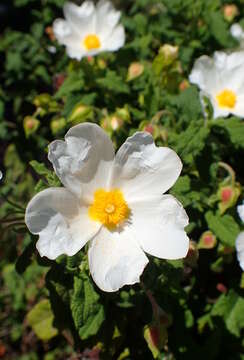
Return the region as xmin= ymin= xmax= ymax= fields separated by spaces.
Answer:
xmin=205 ymin=211 xmax=240 ymax=246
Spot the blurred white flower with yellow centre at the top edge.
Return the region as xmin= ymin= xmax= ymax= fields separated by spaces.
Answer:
xmin=53 ymin=0 xmax=125 ymax=60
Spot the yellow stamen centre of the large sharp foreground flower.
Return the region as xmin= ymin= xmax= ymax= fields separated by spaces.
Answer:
xmin=88 ymin=189 xmax=130 ymax=229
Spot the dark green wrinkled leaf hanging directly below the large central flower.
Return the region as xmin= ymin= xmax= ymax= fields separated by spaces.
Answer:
xmin=71 ymin=276 xmax=105 ymax=340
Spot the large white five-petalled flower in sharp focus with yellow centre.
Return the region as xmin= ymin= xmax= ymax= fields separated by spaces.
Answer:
xmin=26 ymin=123 xmax=189 ymax=291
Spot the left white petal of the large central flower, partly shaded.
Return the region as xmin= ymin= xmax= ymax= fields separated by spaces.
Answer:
xmin=25 ymin=188 xmax=100 ymax=259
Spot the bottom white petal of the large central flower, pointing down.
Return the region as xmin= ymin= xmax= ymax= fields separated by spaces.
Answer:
xmin=88 ymin=228 xmax=148 ymax=292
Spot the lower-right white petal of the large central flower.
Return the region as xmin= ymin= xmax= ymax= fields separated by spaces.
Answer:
xmin=129 ymin=195 xmax=189 ymax=259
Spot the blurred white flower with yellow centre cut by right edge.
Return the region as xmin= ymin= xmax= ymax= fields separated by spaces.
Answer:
xmin=189 ymin=51 xmax=244 ymax=118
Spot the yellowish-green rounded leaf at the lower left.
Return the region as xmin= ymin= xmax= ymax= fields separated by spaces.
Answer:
xmin=27 ymin=299 xmax=58 ymax=340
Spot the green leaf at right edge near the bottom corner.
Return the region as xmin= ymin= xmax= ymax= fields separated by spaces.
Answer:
xmin=211 ymin=290 xmax=244 ymax=337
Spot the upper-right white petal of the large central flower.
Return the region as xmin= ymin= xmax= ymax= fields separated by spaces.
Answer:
xmin=110 ymin=132 xmax=182 ymax=201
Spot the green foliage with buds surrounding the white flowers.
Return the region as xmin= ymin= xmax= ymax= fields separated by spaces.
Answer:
xmin=0 ymin=0 xmax=244 ymax=360
